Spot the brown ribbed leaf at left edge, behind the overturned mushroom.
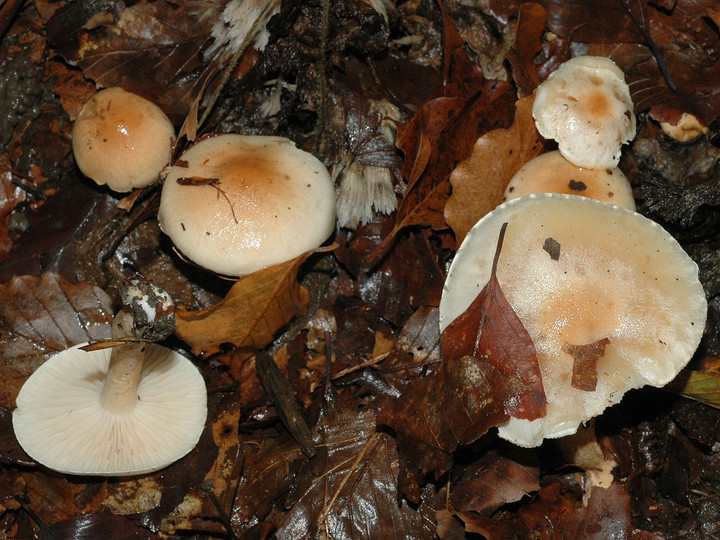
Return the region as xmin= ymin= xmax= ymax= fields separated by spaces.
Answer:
xmin=0 ymin=273 xmax=112 ymax=409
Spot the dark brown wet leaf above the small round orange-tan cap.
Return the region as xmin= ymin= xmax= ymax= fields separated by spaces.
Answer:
xmin=50 ymin=2 xmax=213 ymax=119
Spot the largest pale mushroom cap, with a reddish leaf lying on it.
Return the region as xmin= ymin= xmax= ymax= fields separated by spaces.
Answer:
xmin=440 ymin=194 xmax=707 ymax=446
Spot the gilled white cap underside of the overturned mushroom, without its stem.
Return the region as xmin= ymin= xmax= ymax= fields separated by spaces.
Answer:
xmin=13 ymin=344 xmax=207 ymax=476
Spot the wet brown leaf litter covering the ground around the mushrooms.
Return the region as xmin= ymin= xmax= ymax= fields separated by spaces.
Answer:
xmin=0 ymin=0 xmax=720 ymax=539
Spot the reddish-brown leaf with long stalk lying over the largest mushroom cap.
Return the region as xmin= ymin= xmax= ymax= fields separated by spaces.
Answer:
xmin=379 ymin=227 xmax=546 ymax=501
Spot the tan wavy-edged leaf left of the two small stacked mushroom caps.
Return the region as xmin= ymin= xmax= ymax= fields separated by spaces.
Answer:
xmin=445 ymin=96 xmax=543 ymax=243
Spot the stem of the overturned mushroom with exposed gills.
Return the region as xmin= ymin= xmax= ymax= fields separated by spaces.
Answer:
xmin=100 ymin=309 xmax=146 ymax=413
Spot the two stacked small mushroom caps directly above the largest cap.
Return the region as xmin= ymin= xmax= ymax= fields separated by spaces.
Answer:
xmin=510 ymin=56 xmax=636 ymax=210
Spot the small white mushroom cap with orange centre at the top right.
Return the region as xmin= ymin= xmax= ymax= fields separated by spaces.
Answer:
xmin=532 ymin=56 xmax=636 ymax=169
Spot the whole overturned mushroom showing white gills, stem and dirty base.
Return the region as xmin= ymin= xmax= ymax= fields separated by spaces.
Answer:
xmin=13 ymin=283 xmax=207 ymax=476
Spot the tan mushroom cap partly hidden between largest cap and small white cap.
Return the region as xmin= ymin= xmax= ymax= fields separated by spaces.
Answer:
xmin=503 ymin=150 xmax=635 ymax=210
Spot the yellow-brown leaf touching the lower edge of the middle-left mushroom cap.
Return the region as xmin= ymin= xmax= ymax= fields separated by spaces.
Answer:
xmin=175 ymin=246 xmax=333 ymax=355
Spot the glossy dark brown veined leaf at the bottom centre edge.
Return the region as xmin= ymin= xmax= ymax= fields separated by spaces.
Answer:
xmin=276 ymin=403 xmax=433 ymax=540
